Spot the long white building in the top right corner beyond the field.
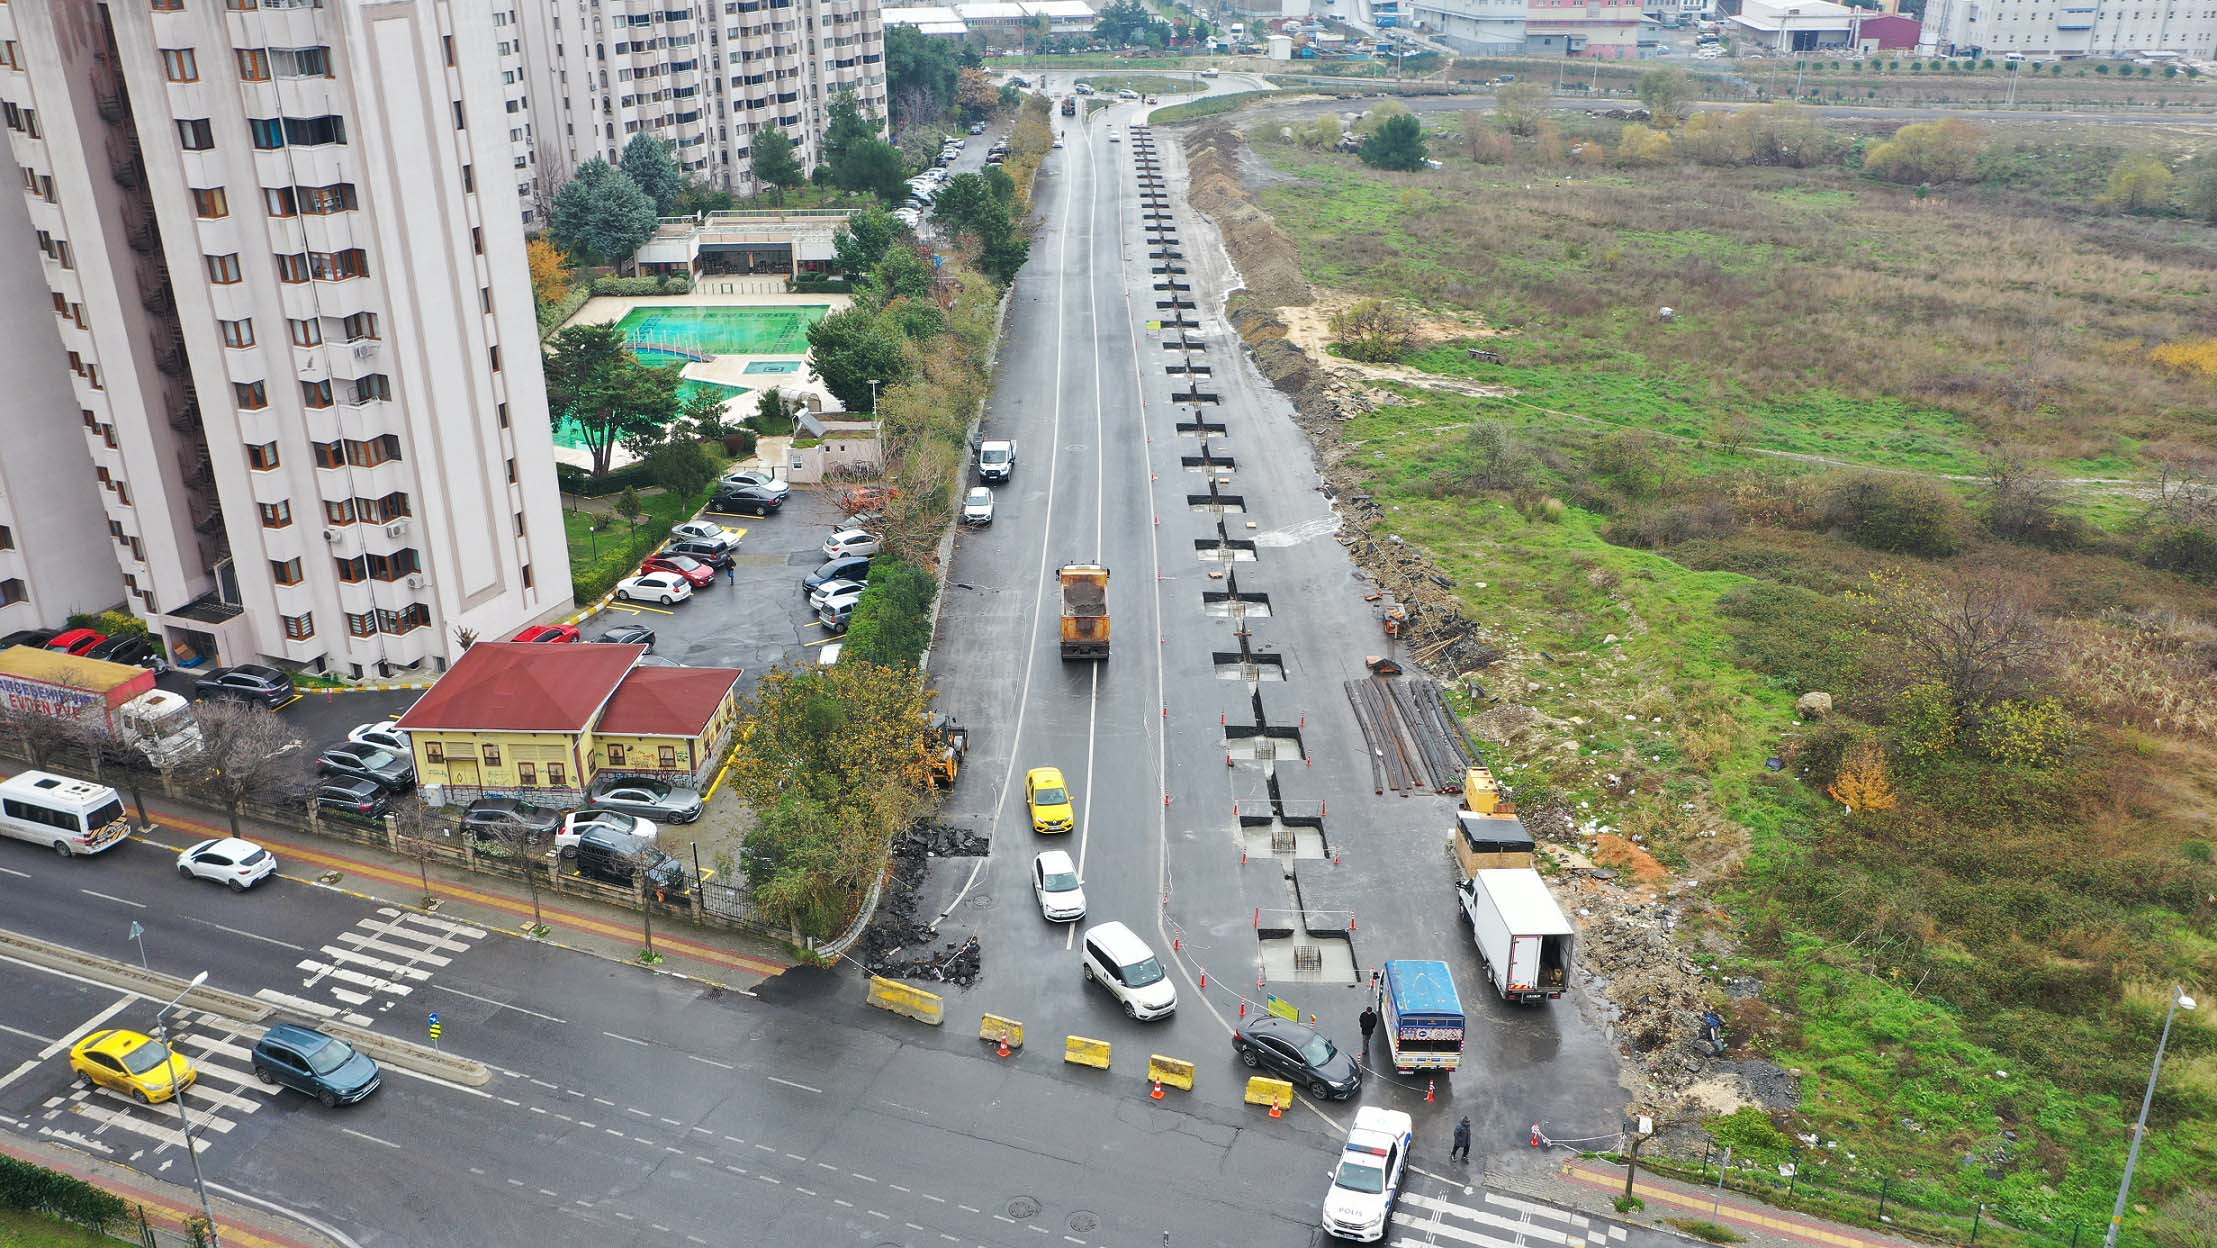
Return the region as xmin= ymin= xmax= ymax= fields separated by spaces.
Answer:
xmin=1918 ymin=0 xmax=2217 ymax=60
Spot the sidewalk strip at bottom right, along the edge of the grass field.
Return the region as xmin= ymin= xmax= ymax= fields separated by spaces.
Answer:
xmin=1485 ymin=1157 xmax=1924 ymax=1248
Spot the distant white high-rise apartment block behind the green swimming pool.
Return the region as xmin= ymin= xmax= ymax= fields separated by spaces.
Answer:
xmin=510 ymin=0 xmax=885 ymax=195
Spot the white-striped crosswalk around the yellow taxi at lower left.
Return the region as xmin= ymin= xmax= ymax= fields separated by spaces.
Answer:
xmin=38 ymin=1011 xmax=277 ymax=1170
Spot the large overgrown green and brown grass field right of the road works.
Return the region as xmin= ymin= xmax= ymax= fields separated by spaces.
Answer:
xmin=1250 ymin=120 xmax=2217 ymax=1248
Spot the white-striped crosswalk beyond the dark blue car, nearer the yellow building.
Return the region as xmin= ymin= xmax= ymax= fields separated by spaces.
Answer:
xmin=255 ymin=907 xmax=486 ymax=1026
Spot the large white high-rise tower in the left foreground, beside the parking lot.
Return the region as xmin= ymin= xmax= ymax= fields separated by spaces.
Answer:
xmin=0 ymin=0 xmax=570 ymax=676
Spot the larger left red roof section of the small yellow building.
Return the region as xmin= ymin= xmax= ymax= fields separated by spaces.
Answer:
xmin=399 ymin=641 xmax=647 ymax=732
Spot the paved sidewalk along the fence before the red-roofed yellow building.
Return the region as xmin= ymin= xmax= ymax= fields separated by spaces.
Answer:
xmin=119 ymin=794 xmax=791 ymax=989
